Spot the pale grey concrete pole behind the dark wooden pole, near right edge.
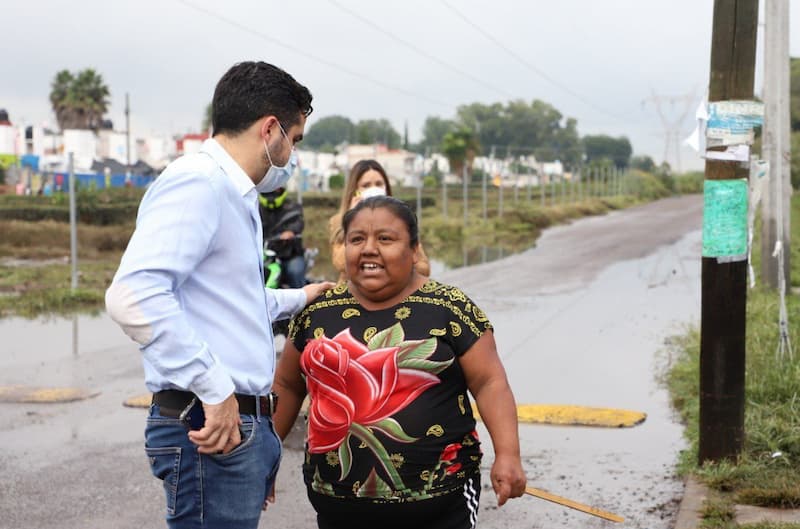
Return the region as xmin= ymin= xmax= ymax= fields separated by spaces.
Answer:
xmin=761 ymin=0 xmax=792 ymax=293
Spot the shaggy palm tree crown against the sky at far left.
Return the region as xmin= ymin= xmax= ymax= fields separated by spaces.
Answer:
xmin=50 ymin=68 xmax=110 ymax=130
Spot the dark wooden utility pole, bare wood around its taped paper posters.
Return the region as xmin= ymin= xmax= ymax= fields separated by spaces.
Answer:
xmin=698 ymin=0 xmax=758 ymax=464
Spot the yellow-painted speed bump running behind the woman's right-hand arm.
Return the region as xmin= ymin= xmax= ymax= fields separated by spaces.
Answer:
xmin=472 ymin=404 xmax=647 ymax=428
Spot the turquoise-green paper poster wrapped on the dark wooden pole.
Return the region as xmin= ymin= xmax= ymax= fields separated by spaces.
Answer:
xmin=703 ymin=178 xmax=748 ymax=262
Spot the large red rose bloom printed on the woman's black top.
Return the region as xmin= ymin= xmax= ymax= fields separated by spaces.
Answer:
xmin=300 ymin=329 xmax=440 ymax=454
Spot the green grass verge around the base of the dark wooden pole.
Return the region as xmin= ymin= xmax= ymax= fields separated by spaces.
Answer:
xmin=666 ymin=195 xmax=800 ymax=529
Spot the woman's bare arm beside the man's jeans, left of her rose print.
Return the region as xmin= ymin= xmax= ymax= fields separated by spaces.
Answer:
xmin=272 ymin=340 xmax=306 ymax=439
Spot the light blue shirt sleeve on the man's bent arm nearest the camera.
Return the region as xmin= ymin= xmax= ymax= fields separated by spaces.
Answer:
xmin=106 ymin=171 xmax=234 ymax=404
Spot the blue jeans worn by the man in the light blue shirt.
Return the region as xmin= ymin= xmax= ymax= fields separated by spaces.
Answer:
xmin=145 ymin=404 xmax=281 ymax=529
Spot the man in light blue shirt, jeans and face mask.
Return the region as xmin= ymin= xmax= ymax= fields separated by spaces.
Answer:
xmin=106 ymin=62 xmax=333 ymax=528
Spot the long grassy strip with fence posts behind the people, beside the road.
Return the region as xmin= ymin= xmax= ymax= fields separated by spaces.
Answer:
xmin=0 ymin=172 xmax=670 ymax=317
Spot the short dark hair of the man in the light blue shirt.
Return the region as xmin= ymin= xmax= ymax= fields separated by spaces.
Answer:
xmin=211 ymin=61 xmax=313 ymax=136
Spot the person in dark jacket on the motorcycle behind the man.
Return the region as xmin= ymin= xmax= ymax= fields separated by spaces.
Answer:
xmin=258 ymin=187 xmax=306 ymax=288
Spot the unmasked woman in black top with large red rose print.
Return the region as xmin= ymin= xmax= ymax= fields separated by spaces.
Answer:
xmin=273 ymin=196 xmax=525 ymax=529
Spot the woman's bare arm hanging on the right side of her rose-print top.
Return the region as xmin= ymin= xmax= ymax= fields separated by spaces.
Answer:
xmin=458 ymin=331 xmax=527 ymax=505
